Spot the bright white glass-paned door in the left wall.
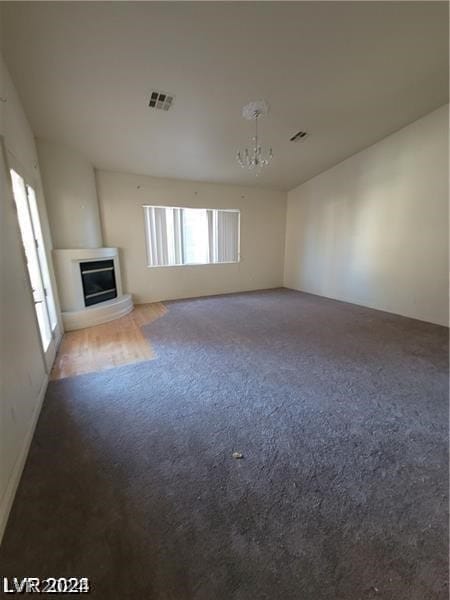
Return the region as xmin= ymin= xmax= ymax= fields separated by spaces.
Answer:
xmin=11 ymin=169 xmax=58 ymax=370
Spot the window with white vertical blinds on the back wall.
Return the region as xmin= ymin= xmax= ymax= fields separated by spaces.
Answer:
xmin=144 ymin=206 xmax=240 ymax=267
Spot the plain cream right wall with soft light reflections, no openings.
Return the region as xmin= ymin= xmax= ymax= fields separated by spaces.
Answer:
xmin=284 ymin=106 xmax=448 ymax=325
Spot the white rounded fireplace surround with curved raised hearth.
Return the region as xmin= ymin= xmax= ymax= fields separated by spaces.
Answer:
xmin=53 ymin=248 xmax=133 ymax=331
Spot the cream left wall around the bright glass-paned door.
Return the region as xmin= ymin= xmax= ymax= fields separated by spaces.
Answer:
xmin=0 ymin=55 xmax=60 ymax=539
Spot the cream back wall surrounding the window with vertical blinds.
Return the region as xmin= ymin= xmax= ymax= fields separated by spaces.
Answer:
xmin=97 ymin=171 xmax=286 ymax=303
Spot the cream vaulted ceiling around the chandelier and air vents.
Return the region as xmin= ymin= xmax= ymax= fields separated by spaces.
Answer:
xmin=1 ymin=1 xmax=448 ymax=190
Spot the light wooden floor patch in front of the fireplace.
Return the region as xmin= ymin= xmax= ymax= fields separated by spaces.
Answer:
xmin=50 ymin=302 xmax=167 ymax=380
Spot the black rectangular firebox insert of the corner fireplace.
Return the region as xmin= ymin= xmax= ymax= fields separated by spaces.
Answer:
xmin=80 ymin=260 xmax=117 ymax=306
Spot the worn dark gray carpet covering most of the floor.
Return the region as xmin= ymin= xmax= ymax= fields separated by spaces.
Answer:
xmin=0 ymin=290 xmax=448 ymax=600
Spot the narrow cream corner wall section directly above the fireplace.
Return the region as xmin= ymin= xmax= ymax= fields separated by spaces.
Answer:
xmin=37 ymin=139 xmax=102 ymax=248
